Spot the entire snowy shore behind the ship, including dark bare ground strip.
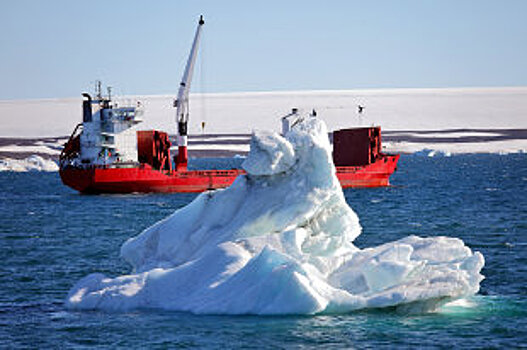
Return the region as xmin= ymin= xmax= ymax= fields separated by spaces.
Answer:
xmin=0 ymin=87 xmax=527 ymax=167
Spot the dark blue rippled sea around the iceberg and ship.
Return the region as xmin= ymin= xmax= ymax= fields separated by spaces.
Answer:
xmin=0 ymin=154 xmax=527 ymax=349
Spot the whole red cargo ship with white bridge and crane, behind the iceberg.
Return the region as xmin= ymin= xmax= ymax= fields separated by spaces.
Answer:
xmin=59 ymin=17 xmax=399 ymax=193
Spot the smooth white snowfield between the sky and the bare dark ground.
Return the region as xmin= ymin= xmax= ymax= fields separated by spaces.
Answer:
xmin=0 ymin=87 xmax=527 ymax=138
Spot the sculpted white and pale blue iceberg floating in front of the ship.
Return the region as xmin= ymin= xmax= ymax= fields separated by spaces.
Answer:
xmin=66 ymin=118 xmax=484 ymax=314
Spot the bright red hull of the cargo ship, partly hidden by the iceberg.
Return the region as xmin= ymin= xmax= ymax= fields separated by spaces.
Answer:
xmin=60 ymin=155 xmax=399 ymax=193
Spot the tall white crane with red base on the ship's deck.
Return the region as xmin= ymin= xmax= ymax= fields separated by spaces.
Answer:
xmin=175 ymin=16 xmax=205 ymax=170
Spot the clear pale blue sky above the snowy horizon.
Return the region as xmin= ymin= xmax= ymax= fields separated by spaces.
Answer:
xmin=0 ymin=0 xmax=527 ymax=99
